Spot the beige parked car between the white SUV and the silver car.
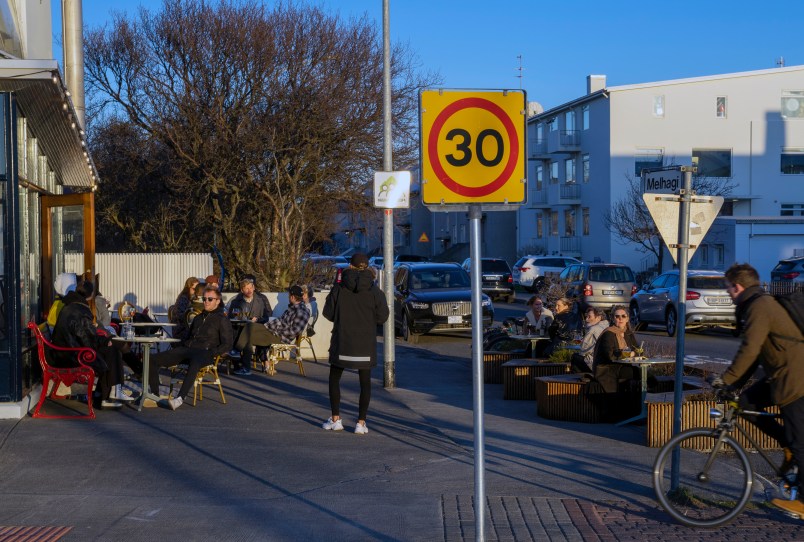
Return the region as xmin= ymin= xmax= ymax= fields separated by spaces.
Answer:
xmin=558 ymin=263 xmax=637 ymax=314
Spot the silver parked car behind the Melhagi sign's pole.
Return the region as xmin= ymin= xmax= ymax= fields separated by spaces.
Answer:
xmin=630 ymin=269 xmax=736 ymax=337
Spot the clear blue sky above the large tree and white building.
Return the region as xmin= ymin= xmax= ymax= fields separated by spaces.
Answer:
xmin=64 ymin=0 xmax=804 ymax=109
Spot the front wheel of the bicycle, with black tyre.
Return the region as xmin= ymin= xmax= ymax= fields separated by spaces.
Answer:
xmin=653 ymin=428 xmax=754 ymax=527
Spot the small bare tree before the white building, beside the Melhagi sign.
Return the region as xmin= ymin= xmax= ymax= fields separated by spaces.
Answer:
xmin=603 ymin=174 xmax=732 ymax=269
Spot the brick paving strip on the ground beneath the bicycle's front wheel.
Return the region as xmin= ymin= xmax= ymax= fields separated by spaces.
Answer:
xmin=441 ymin=495 xmax=804 ymax=542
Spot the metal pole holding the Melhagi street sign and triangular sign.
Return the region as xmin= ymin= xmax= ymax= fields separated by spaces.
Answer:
xmin=670 ymin=167 xmax=692 ymax=489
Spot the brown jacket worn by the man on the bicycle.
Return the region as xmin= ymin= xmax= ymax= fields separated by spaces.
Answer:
xmin=723 ymin=286 xmax=804 ymax=406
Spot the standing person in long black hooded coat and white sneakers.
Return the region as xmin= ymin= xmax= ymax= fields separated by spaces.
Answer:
xmin=322 ymin=254 xmax=389 ymax=435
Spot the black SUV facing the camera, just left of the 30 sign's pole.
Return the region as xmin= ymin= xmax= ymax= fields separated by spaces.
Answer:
xmin=394 ymin=263 xmax=494 ymax=343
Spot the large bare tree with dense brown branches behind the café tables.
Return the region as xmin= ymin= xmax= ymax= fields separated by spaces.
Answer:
xmin=85 ymin=0 xmax=437 ymax=288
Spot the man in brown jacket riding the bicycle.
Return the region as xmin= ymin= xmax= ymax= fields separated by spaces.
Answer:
xmin=712 ymin=264 xmax=804 ymax=517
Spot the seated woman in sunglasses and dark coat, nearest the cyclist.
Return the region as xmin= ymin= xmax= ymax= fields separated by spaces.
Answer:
xmin=592 ymin=305 xmax=639 ymax=418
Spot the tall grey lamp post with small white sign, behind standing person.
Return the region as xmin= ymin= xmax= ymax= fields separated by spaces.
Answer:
xmin=382 ymin=0 xmax=396 ymax=389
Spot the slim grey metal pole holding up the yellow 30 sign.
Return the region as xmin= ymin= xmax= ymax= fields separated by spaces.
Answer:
xmin=469 ymin=204 xmax=486 ymax=542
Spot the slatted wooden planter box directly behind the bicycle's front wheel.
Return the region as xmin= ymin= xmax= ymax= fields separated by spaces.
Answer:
xmin=647 ymin=400 xmax=781 ymax=451
